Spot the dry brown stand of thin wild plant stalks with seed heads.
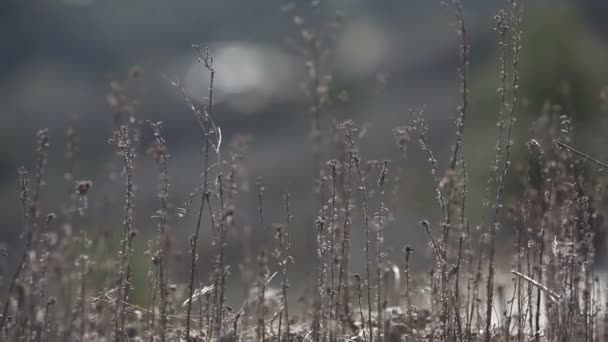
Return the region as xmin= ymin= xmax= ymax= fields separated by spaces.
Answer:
xmin=0 ymin=0 xmax=608 ymax=342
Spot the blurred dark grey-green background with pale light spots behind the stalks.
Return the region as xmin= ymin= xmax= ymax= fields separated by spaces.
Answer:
xmin=0 ymin=0 xmax=608 ymax=304
